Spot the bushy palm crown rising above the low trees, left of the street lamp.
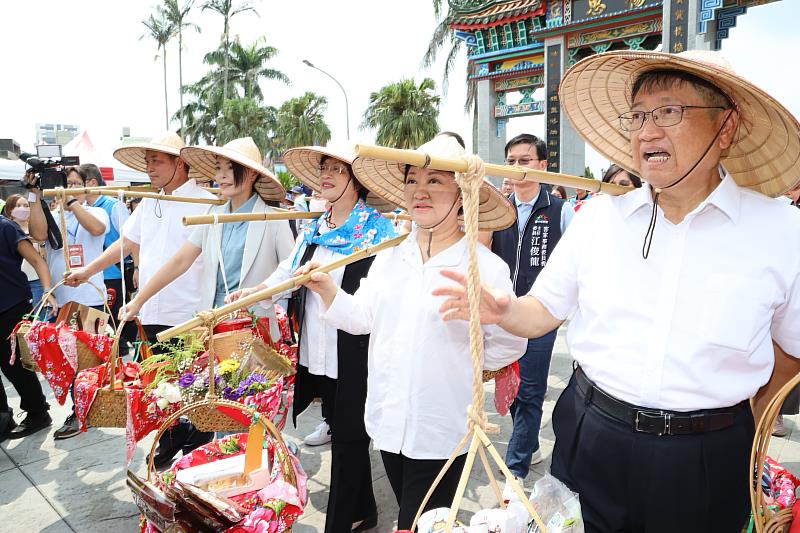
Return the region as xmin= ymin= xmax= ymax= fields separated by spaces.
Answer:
xmin=203 ymin=37 xmax=289 ymax=101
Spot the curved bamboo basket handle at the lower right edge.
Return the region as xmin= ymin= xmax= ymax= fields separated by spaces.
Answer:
xmin=750 ymin=374 xmax=800 ymax=533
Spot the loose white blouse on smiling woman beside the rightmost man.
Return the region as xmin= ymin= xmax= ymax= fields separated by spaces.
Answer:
xmin=324 ymin=230 xmax=527 ymax=459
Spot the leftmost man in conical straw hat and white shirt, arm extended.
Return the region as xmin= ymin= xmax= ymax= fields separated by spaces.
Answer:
xmin=66 ymin=132 xmax=219 ymax=457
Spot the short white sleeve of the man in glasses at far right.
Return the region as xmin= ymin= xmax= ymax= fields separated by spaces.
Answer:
xmin=528 ymin=197 xmax=597 ymax=320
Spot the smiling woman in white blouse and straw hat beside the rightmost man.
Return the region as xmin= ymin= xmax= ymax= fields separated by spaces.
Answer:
xmin=300 ymin=136 xmax=526 ymax=530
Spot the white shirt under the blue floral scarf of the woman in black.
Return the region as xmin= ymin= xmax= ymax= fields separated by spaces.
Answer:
xmin=264 ymin=222 xmax=344 ymax=379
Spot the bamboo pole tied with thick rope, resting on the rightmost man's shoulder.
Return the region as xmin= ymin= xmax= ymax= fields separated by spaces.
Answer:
xmin=356 ymin=144 xmax=633 ymax=196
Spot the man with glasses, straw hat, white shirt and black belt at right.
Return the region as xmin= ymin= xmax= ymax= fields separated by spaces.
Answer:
xmin=437 ymin=51 xmax=800 ymax=532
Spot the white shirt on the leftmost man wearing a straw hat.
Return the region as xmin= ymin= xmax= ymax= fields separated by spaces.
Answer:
xmin=122 ymin=179 xmax=214 ymax=326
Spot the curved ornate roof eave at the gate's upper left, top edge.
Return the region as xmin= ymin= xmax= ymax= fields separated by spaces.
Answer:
xmin=448 ymin=0 xmax=545 ymax=30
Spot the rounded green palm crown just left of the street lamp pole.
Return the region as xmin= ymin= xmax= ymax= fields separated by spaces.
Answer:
xmin=274 ymin=92 xmax=331 ymax=153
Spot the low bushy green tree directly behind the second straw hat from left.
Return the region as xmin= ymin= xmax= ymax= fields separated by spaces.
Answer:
xmin=217 ymin=98 xmax=277 ymax=153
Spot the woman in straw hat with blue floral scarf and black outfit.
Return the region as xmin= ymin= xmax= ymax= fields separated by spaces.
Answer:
xmin=230 ymin=142 xmax=394 ymax=533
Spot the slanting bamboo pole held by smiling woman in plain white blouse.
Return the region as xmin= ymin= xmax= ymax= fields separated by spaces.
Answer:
xmin=156 ymin=234 xmax=408 ymax=342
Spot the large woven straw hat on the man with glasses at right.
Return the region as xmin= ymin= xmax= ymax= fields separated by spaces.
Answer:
xmin=559 ymin=50 xmax=800 ymax=197
